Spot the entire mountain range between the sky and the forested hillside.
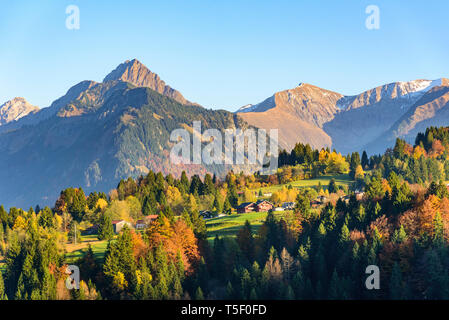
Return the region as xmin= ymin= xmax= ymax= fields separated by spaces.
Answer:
xmin=0 ymin=59 xmax=449 ymax=207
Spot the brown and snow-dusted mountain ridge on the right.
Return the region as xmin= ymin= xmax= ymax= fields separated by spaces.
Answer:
xmin=237 ymin=79 xmax=449 ymax=153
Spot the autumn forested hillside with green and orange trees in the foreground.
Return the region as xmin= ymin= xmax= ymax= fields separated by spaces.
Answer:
xmin=0 ymin=128 xmax=449 ymax=300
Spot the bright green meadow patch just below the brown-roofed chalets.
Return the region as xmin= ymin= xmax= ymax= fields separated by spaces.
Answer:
xmin=206 ymin=212 xmax=283 ymax=241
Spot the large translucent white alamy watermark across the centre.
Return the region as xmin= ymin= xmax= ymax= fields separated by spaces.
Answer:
xmin=170 ymin=121 xmax=279 ymax=174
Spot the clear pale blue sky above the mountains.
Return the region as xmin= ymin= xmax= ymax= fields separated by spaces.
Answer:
xmin=0 ymin=0 xmax=449 ymax=111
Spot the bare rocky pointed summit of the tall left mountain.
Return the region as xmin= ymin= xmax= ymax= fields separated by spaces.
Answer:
xmin=103 ymin=59 xmax=190 ymax=104
